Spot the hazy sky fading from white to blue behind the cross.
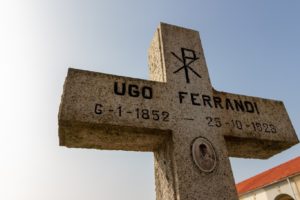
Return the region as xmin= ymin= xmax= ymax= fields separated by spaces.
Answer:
xmin=0 ymin=0 xmax=300 ymax=200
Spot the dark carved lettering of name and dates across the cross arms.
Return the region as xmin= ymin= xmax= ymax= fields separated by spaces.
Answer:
xmin=94 ymin=81 xmax=278 ymax=134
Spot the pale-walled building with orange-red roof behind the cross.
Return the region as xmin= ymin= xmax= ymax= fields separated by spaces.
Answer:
xmin=236 ymin=157 xmax=300 ymax=200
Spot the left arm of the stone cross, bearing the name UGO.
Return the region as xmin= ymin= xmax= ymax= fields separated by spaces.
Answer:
xmin=59 ymin=69 xmax=172 ymax=151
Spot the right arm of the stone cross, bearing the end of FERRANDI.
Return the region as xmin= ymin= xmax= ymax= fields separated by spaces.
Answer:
xmin=207 ymin=90 xmax=299 ymax=158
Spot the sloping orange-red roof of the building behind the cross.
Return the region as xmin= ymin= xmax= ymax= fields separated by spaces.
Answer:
xmin=236 ymin=156 xmax=300 ymax=195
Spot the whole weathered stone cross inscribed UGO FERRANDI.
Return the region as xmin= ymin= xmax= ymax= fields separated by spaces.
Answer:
xmin=59 ymin=23 xmax=298 ymax=200
